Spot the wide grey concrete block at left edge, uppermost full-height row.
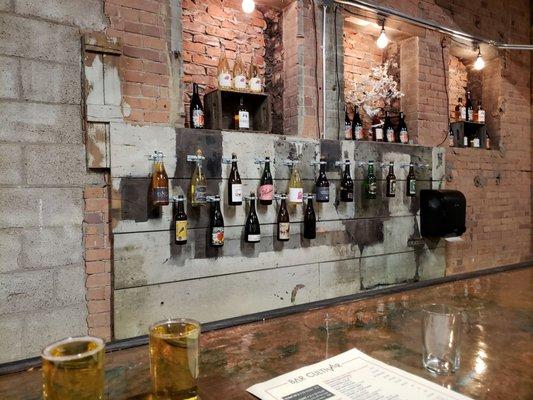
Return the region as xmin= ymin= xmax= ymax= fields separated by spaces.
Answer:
xmin=0 ymin=13 xmax=82 ymax=65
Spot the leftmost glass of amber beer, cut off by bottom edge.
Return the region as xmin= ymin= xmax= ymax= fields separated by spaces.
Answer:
xmin=41 ymin=336 xmax=105 ymax=400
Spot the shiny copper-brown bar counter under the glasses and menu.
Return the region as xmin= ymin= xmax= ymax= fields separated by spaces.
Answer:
xmin=0 ymin=267 xmax=533 ymax=400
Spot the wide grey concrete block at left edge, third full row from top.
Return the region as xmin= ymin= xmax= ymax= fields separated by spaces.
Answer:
xmin=0 ymin=101 xmax=83 ymax=144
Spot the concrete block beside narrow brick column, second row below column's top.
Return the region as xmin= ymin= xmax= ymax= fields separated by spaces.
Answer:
xmin=22 ymin=224 xmax=83 ymax=268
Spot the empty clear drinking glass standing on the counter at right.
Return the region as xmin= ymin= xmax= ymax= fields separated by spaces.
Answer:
xmin=422 ymin=304 xmax=461 ymax=375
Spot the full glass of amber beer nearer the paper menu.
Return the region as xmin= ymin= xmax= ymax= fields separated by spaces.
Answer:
xmin=150 ymin=318 xmax=200 ymax=400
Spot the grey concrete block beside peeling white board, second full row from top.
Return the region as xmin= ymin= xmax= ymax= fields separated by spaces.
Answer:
xmin=21 ymin=59 xmax=81 ymax=104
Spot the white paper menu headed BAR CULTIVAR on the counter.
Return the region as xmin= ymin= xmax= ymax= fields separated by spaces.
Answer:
xmin=248 ymin=349 xmax=469 ymax=400
